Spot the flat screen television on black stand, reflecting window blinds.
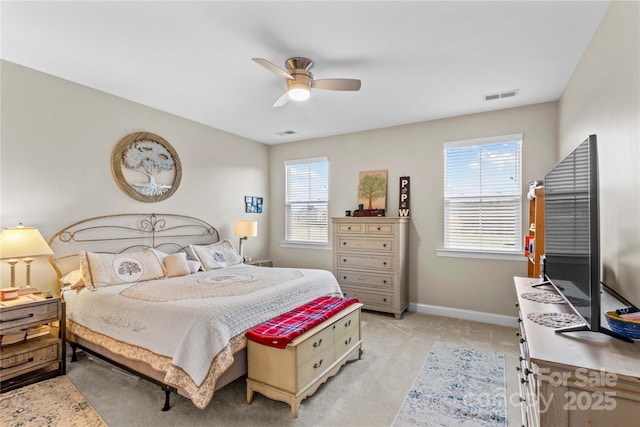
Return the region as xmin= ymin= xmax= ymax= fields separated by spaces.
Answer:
xmin=543 ymin=135 xmax=629 ymax=341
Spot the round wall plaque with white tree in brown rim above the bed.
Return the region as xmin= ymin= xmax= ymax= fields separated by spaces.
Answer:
xmin=111 ymin=132 xmax=182 ymax=202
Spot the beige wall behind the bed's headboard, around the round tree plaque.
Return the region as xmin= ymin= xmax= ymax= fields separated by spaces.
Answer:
xmin=0 ymin=61 xmax=269 ymax=291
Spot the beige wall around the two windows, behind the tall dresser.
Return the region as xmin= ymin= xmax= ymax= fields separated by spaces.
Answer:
xmin=269 ymin=103 xmax=557 ymax=315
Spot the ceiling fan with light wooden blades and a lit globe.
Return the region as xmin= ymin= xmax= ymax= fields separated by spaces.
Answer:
xmin=252 ymin=56 xmax=361 ymax=107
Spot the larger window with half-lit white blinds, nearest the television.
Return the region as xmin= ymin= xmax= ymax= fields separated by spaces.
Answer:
xmin=444 ymin=134 xmax=522 ymax=253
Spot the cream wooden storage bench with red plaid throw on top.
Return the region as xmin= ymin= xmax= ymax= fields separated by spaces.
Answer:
xmin=246 ymin=296 xmax=364 ymax=418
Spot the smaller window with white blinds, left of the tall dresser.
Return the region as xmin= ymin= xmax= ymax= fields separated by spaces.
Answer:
xmin=285 ymin=157 xmax=329 ymax=244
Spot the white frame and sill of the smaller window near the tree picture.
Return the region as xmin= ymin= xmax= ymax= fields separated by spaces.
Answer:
xmin=280 ymin=156 xmax=331 ymax=249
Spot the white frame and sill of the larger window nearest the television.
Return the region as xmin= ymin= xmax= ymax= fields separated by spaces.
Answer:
xmin=436 ymin=133 xmax=526 ymax=262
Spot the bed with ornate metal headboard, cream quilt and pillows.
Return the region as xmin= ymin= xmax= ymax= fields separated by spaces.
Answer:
xmin=49 ymin=214 xmax=342 ymax=410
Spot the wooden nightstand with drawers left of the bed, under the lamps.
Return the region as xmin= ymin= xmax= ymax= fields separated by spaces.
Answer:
xmin=0 ymin=294 xmax=66 ymax=392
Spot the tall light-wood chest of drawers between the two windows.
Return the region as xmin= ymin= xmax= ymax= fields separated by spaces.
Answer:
xmin=332 ymin=217 xmax=409 ymax=319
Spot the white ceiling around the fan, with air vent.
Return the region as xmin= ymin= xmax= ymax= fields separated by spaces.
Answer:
xmin=0 ymin=1 xmax=609 ymax=144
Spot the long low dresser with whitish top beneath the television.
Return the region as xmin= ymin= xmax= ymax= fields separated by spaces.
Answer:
xmin=514 ymin=277 xmax=640 ymax=427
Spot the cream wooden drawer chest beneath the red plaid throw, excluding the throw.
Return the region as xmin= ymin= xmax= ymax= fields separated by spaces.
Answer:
xmin=247 ymin=304 xmax=363 ymax=418
